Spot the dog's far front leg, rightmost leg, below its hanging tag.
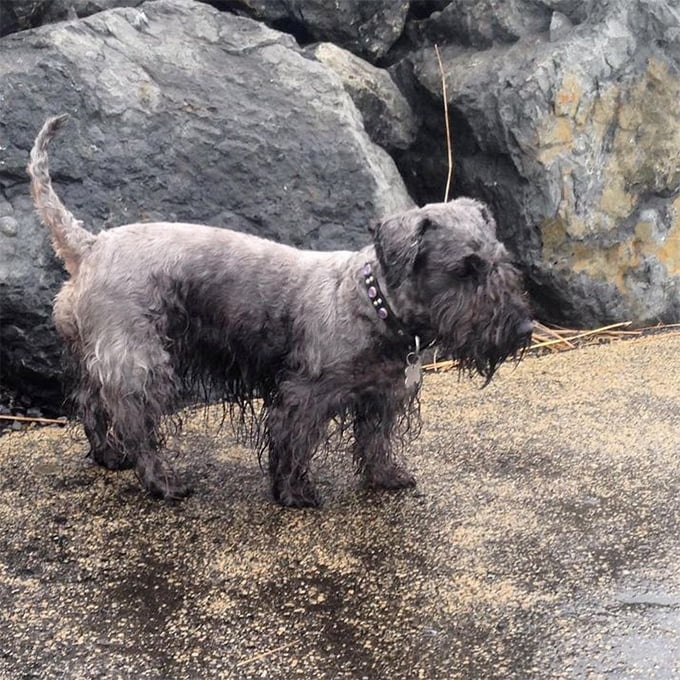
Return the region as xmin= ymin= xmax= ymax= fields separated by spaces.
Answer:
xmin=353 ymin=394 xmax=416 ymax=489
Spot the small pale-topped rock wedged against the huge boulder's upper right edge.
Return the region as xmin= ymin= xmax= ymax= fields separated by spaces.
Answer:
xmin=311 ymin=43 xmax=418 ymax=150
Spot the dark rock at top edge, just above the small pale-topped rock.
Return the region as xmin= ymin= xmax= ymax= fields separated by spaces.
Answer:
xmin=211 ymin=0 xmax=409 ymax=61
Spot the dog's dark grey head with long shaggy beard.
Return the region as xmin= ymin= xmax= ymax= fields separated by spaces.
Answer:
xmin=373 ymin=198 xmax=532 ymax=380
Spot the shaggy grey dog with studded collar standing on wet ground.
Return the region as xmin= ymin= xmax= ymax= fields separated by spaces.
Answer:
xmin=28 ymin=116 xmax=532 ymax=507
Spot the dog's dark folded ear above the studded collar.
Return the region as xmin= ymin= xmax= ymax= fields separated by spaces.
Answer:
xmin=371 ymin=210 xmax=436 ymax=289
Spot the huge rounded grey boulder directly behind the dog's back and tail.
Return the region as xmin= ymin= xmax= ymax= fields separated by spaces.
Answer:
xmin=0 ymin=0 xmax=412 ymax=406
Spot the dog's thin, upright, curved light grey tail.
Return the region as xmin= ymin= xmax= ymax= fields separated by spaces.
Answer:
xmin=27 ymin=115 xmax=96 ymax=276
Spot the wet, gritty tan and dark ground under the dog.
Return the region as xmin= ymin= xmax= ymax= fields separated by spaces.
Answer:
xmin=0 ymin=336 xmax=680 ymax=680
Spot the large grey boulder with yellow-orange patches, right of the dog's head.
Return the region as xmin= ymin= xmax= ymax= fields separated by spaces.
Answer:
xmin=398 ymin=0 xmax=680 ymax=326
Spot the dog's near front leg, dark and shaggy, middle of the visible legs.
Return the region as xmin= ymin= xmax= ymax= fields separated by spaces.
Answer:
xmin=267 ymin=381 xmax=328 ymax=508
